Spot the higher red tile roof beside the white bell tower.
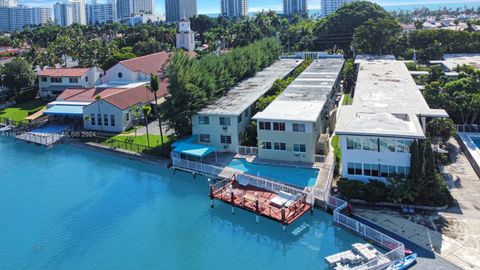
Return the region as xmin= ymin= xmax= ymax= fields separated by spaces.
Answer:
xmin=119 ymin=52 xmax=171 ymax=74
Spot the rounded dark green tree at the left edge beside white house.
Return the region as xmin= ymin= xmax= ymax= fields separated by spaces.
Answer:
xmin=0 ymin=57 xmax=35 ymax=93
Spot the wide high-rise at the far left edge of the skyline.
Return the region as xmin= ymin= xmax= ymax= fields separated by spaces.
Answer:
xmin=0 ymin=6 xmax=52 ymax=32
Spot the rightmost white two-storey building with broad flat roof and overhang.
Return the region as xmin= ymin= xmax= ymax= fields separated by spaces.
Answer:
xmin=335 ymin=56 xmax=448 ymax=181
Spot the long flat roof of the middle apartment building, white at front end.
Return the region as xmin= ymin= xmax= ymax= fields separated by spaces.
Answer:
xmin=253 ymin=58 xmax=345 ymax=122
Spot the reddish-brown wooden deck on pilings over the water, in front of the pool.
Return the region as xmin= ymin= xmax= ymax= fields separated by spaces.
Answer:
xmin=210 ymin=179 xmax=312 ymax=225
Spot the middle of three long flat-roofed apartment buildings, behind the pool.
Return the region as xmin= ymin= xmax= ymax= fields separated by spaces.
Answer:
xmin=253 ymin=57 xmax=344 ymax=163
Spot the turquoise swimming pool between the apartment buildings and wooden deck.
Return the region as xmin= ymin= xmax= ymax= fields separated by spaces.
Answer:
xmin=227 ymin=159 xmax=319 ymax=188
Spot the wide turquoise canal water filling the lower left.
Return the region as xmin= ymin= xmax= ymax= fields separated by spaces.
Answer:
xmin=0 ymin=137 xmax=363 ymax=270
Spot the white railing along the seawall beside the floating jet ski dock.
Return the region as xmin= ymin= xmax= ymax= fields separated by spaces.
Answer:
xmin=327 ymin=196 xmax=405 ymax=270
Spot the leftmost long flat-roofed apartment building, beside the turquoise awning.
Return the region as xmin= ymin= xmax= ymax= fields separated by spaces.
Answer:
xmin=192 ymin=60 xmax=302 ymax=153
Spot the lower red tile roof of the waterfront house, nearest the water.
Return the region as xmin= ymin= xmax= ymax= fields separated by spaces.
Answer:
xmin=103 ymin=85 xmax=158 ymax=110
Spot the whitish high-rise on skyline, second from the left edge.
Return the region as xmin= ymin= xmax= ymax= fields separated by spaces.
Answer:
xmin=53 ymin=0 xmax=87 ymax=26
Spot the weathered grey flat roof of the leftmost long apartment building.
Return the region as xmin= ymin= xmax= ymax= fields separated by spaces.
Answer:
xmin=198 ymin=59 xmax=302 ymax=116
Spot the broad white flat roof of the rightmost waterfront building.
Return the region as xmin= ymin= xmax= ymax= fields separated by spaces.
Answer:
xmin=335 ymin=59 xmax=448 ymax=139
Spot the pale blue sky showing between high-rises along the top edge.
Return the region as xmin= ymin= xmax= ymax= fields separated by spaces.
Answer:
xmin=18 ymin=0 xmax=480 ymax=14
